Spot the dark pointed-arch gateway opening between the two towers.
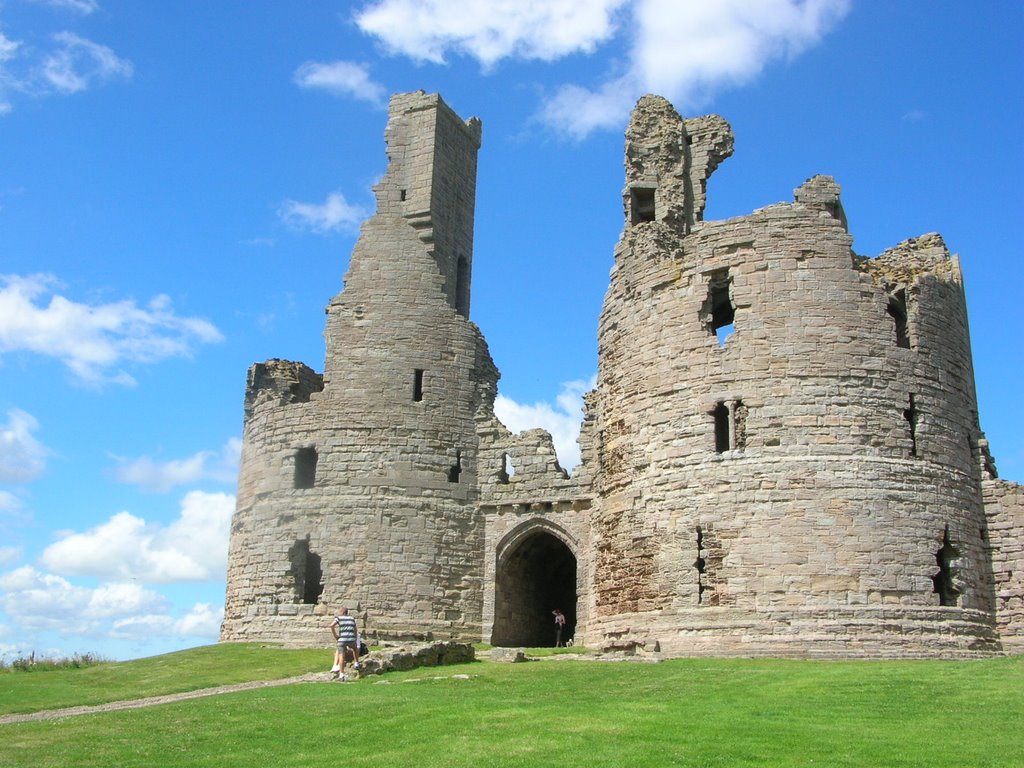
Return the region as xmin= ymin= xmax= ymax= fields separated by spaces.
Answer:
xmin=490 ymin=527 xmax=577 ymax=647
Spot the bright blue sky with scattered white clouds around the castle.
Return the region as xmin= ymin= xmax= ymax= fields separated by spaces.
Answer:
xmin=0 ymin=0 xmax=1024 ymax=658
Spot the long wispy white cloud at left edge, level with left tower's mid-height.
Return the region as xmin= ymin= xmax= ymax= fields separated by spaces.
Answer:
xmin=0 ymin=274 xmax=223 ymax=385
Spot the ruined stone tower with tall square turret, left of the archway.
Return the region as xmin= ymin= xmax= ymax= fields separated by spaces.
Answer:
xmin=221 ymin=91 xmax=498 ymax=644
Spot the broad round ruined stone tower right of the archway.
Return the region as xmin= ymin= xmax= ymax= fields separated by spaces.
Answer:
xmin=587 ymin=96 xmax=998 ymax=655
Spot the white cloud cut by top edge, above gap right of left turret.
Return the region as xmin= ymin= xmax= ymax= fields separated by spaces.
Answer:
xmin=355 ymin=0 xmax=627 ymax=67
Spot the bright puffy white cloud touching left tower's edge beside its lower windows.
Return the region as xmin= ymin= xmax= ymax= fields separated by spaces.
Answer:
xmin=40 ymin=490 xmax=234 ymax=584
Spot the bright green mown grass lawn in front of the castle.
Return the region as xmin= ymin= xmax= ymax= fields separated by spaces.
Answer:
xmin=0 ymin=646 xmax=1024 ymax=768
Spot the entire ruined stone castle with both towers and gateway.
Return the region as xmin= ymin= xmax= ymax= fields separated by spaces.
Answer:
xmin=222 ymin=88 xmax=1024 ymax=656
